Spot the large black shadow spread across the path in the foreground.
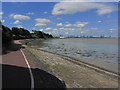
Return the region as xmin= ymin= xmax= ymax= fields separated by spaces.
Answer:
xmin=2 ymin=64 xmax=66 ymax=90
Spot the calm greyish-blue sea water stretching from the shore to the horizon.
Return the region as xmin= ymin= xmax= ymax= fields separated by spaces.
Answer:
xmin=29 ymin=38 xmax=119 ymax=72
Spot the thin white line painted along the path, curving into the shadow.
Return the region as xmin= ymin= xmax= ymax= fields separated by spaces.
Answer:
xmin=20 ymin=49 xmax=34 ymax=90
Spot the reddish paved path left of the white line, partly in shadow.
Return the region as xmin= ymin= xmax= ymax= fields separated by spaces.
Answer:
xmin=2 ymin=42 xmax=31 ymax=88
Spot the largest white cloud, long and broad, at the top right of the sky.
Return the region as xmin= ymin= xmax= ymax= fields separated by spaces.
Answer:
xmin=52 ymin=2 xmax=116 ymax=15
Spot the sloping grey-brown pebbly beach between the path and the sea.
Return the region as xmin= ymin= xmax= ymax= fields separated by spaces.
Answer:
xmin=21 ymin=42 xmax=118 ymax=88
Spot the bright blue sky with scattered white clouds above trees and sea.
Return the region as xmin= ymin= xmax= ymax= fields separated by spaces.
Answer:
xmin=0 ymin=0 xmax=118 ymax=37
